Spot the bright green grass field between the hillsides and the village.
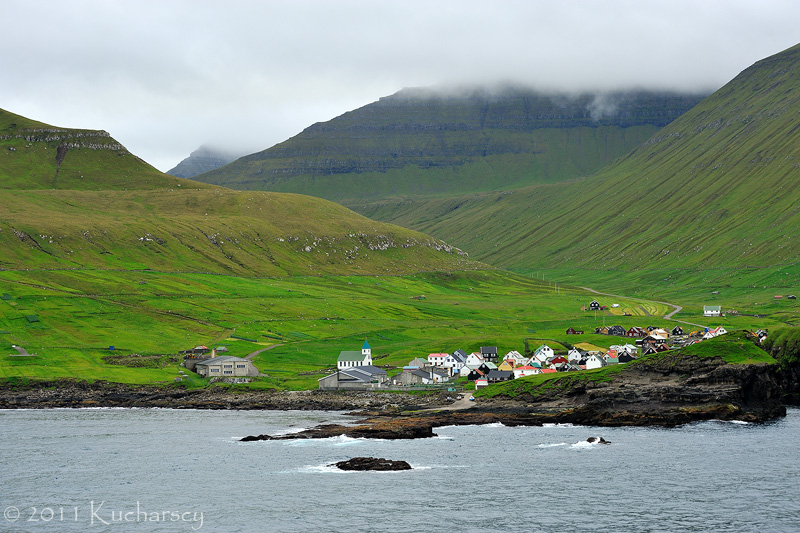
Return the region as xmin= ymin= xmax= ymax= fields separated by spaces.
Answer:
xmin=0 ymin=270 xmax=776 ymax=389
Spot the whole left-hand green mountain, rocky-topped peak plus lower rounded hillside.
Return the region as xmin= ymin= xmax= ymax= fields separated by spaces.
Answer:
xmin=0 ymin=107 xmax=475 ymax=276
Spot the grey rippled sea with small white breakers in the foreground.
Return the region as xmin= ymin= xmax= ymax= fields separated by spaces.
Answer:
xmin=0 ymin=408 xmax=800 ymax=533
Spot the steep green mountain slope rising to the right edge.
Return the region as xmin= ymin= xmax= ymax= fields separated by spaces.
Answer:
xmin=361 ymin=45 xmax=800 ymax=271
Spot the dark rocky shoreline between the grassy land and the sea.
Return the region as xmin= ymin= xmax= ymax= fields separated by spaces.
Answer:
xmin=0 ymin=355 xmax=796 ymax=432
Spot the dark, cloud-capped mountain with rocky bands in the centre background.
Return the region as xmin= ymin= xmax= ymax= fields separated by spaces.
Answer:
xmin=195 ymin=88 xmax=701 ymax=201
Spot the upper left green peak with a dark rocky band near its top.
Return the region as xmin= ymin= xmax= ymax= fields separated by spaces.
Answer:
xmin=0 ymin=109 xmax=198 ymax=190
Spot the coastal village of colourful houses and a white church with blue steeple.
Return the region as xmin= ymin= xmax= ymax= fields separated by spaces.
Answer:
xmin=176 ymin=300 xmax=767 ymax=390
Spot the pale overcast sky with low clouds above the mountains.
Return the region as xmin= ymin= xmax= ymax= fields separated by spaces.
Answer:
xmin=0 ymin=0 xmax=800 ymax=171
